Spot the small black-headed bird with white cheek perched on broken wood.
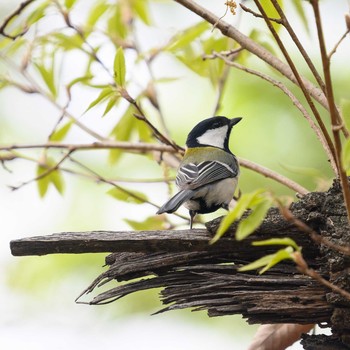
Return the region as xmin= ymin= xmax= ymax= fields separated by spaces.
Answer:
xmin=157 ymin=116 xmax=242 ymax=229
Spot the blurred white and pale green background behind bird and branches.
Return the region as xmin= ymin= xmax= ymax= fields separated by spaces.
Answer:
xmin=0 ymin=0 xmax=350 ymax=350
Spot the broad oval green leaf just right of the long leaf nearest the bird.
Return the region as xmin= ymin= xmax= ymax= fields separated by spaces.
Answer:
xmin=236 ymin=198 xmax=272 ymax=241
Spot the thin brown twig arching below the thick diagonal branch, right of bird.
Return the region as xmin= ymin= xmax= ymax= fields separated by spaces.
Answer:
xmin=205 ymin=52 xmax=338 ymax=173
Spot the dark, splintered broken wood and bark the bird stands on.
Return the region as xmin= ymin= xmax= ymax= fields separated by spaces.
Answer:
xmin=11 ymin=182 xmax=350 ymax=349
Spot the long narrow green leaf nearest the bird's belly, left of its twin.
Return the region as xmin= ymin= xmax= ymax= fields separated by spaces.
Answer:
xmin=210 ymin=189 xmax=265 ymax=243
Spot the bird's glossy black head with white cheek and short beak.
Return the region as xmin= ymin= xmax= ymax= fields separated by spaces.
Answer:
xmin=186 ymin=117 xmax=242 ymax=152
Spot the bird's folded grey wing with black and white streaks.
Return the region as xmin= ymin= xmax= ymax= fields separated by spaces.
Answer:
xmin=176 ymin=161 xmax=238 ymax=190
